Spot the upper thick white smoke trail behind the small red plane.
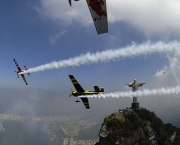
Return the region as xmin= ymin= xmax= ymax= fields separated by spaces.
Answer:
xmin=20 ymin=41 xmax=180 ymax=73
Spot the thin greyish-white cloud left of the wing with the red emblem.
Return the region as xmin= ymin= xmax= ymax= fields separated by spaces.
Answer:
xmin=35 ymin=0 xmax=90 ymax=24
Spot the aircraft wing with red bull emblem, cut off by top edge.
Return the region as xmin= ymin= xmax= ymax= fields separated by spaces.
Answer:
xmin=86 ymin=0 xmax=108 ymax=34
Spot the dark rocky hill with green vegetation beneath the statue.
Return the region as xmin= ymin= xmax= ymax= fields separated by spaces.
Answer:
xmin=96 ymin=108 xmax=180 ymax=145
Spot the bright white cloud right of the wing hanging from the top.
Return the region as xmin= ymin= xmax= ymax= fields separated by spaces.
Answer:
xmin=107 ymin=0 xmax=180 ymax=36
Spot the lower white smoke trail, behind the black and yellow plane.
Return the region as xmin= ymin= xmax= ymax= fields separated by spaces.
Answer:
xmin=83 ymin=86 xmax=180 ymax=98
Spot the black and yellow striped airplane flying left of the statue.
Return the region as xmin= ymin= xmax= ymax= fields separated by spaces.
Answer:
xmin=69 ymin=75 xmax=104 ymax=109
